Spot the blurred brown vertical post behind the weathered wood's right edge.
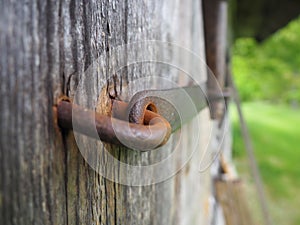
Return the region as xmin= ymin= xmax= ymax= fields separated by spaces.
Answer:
xmin=203 ymin=0 xmax=228 ymax=120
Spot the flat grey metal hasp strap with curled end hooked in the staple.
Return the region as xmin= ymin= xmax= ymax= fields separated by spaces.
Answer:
xmin=128 ymin=84 xmax=208 ymax=132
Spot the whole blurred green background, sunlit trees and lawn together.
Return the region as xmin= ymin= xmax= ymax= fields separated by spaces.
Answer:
xmin=230 ymin=14 xmax=300 ymax=225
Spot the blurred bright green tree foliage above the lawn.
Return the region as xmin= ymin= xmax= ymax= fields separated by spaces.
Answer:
xmin=232 ymin=17 xmax=300 ymax=103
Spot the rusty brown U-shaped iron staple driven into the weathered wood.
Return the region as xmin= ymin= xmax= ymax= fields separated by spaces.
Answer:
xmin=55 ymin=100 xmax=171 ymax=151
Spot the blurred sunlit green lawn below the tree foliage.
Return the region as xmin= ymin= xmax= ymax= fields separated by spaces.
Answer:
xmin=230 ymin=102 xmax=300 ymax=225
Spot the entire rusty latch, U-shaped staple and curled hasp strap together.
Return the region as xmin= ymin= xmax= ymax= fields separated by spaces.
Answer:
xmin=55 ymin=84 xmax=229 ymax=151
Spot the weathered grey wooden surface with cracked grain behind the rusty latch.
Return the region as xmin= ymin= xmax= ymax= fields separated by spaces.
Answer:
xmin=0 ymin=0 xmax=210 ymax=225
